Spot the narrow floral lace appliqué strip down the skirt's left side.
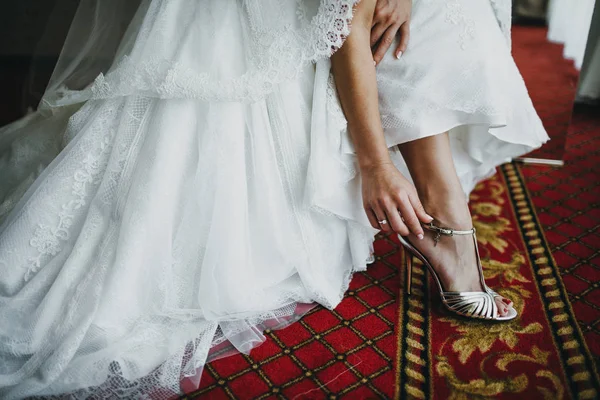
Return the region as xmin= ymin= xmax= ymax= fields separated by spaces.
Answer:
xmin=24 ymin=130 xmax=115 ymax=281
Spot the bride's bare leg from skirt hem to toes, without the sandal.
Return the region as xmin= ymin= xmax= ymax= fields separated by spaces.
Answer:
xmin=399 ymin=133 xmax=510 ymax=315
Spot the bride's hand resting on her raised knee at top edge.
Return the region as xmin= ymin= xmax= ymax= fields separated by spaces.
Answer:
xmin=371 ymin=0 xmax=412 ymax=64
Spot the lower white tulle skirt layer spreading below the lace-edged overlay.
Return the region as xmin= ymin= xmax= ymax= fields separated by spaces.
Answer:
xmin=0 ymin=82 xmax=373 ymax=397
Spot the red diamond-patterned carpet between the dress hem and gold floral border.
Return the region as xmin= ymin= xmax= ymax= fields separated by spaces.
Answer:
xmin=188 ymin=236 xmax=399 ymax=399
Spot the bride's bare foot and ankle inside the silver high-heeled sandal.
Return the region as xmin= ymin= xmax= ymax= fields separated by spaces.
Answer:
xmin=407 ymin=193 xmax=512 ymax=317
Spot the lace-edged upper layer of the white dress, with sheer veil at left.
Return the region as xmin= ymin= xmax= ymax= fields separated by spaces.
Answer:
xmin=43 ymin=0 xmax=364 ymax=107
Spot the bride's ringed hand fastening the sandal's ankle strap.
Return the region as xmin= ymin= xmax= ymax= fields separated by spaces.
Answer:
xmin=361 ymin=163 xmax=433 ymax=239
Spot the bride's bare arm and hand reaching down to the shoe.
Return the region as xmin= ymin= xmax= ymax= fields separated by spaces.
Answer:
xmin=331 ymin=0 xmax=432 ymax=237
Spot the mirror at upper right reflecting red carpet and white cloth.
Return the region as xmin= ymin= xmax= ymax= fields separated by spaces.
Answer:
xmin=513 ymin=0 xmax=598 ymax=165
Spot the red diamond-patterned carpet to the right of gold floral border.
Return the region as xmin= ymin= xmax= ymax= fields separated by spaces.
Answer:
xmin=521 ymin=107 xmax=600 ymax=365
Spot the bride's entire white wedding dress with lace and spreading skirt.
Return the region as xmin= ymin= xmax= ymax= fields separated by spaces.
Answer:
xmin=0 ymin=0 xmax=547 ymax=399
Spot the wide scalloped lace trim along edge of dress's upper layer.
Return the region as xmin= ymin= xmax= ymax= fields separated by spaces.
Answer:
xmin=82 ymin=0 xmax=357 ymax=102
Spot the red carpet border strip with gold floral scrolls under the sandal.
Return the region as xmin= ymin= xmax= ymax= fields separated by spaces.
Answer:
xmin=394 ymin=163 xmax=600 ymax=400
